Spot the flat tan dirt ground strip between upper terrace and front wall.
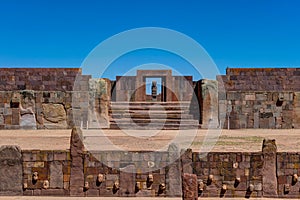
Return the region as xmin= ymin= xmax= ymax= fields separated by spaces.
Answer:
xmin=0 ymin=129 xmax=300 ymax=152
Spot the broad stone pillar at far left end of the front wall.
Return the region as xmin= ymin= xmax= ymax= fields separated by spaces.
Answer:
xmin=0 ymin=146 xmax=23 ymax=196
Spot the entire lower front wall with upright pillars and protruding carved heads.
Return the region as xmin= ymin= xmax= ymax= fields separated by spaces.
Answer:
xmin=0 ymin=129 xmax=300 ymax=199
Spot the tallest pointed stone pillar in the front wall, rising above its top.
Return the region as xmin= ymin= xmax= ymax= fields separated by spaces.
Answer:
xmin=70 ymin=128 xmax=84 ymax=196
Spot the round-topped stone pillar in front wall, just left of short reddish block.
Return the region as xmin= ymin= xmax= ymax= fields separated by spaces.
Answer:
xmin=166 ymin=143 xmax=182 ymax=197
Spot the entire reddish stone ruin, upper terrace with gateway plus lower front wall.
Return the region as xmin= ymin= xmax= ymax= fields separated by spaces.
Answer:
xmin=0 ymin=68 xmax=300 ymax=199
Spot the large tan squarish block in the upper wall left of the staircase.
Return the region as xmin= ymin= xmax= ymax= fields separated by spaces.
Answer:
xmin=42 ymin=103 xmax=67 ymax=129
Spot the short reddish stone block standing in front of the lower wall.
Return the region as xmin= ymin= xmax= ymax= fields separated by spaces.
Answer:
xmin=182 ymin=173 xmax=198 ymax=200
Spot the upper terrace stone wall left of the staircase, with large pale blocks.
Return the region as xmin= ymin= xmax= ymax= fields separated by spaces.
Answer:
xmin=0 ymin=68 xmax=91 ymax=129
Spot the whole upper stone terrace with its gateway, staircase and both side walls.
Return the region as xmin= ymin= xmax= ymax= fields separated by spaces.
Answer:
xmin=0 ymin=68 xmax=300 ymax=129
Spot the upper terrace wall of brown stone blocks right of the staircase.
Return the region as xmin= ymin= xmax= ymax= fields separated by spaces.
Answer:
xmin=217 ymin=68 xmax=300 ymax=129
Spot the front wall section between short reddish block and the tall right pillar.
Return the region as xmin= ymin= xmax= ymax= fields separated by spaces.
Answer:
xmin=193 ymin=152 xmax=263 ymax=197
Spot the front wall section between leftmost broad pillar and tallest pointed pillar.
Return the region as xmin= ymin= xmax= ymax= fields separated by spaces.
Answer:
xmin=22 ymin=150 xmax=71 ymax=196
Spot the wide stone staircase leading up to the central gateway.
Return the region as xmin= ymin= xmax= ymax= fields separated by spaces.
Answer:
xmin=109 ymin=102 xmax=199 ymax=130
